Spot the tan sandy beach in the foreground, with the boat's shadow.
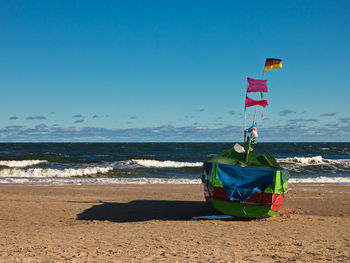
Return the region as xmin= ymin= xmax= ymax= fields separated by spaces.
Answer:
xmin=0 ymin=184 xmax=350 ymax=262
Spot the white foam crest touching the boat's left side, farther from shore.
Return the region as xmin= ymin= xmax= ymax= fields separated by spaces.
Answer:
xmin=123 ymin=159 xmax=203 ymax=168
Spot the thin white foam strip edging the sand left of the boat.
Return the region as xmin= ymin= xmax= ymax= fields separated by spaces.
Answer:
xmin=0 ymin=177 xmax=201 ymax=185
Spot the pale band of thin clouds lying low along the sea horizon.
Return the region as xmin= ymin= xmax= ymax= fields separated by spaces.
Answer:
xmin=0 ymin=119 xmax=350 ymax=142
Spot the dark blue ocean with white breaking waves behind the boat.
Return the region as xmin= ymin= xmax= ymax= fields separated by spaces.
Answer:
xmin=0 ymin=143 xmax=350 ymax=184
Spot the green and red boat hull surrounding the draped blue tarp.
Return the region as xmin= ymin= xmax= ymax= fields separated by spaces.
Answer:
xmin=202 ymin=150 xmax=289 ymax=218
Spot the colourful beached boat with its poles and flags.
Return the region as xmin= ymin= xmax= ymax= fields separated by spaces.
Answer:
xmin=202 ymin=59 xmax=290 ymax=218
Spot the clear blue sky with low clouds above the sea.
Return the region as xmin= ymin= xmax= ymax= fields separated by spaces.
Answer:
xmin=0 ymin=0 xmax=350 ymax=142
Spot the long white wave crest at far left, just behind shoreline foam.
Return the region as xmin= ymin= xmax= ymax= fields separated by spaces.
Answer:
xmin=0 ymin=166 xmax=113 ymax=178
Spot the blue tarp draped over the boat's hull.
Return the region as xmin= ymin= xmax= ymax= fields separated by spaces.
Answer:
xmin=217 ymin=163 xmax=276 ymax=202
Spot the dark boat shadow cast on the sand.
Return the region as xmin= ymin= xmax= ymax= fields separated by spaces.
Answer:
xmin=72 ymin=200 xmax=228 ymax=223
